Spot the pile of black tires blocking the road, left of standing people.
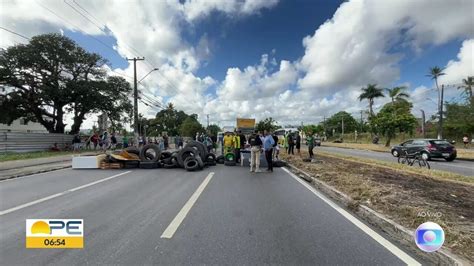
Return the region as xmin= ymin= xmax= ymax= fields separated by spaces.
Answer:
xmin=125 ymin=141 xmax=216 ymax=171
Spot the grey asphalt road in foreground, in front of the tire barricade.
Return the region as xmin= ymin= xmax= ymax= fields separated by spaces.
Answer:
xmin=0 ymin=165 xmax=423 ymax=265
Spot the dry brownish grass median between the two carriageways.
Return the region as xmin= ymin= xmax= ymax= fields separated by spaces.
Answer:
xmin=282 ymin=154 xmax=474 ymax=261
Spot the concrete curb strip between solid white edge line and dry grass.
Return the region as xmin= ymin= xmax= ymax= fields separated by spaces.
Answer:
xmin=288 ymin=163 xmax=470 ymax=265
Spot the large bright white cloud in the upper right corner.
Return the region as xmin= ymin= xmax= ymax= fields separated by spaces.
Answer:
xmin=299 ymin=0 xmax=474 ymax=95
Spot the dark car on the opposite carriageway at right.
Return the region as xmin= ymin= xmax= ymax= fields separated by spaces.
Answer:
xmin=392 ymin=139 xmax=457 ymax=162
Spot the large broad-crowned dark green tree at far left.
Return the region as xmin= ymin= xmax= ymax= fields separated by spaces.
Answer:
xmin=0 ymin=34 xmax=130 ymax=133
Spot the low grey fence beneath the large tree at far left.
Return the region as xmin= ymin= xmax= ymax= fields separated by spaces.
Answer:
xmin=0 ymin=132 xmax=73 ymax=152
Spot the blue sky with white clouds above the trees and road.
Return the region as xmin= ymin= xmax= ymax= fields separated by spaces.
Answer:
xmin=0 ymin=0 xmax=474 ymax=128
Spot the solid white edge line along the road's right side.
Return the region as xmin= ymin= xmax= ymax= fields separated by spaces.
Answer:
xmin=283 ymin=168 xmax=421 ymax=265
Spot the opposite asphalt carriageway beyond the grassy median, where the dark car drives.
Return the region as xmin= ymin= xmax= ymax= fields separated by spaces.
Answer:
xmin=314 ymin=145 xmax=474 ymax=176
